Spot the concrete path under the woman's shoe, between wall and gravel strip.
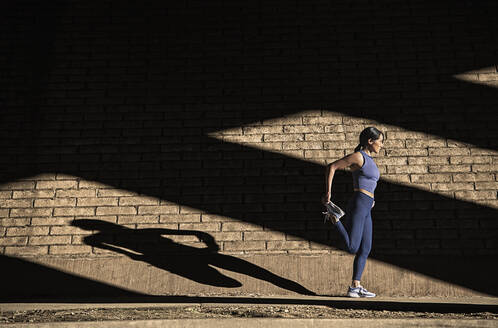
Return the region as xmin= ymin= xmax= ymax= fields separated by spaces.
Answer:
xmin=0 ymin=295 xmax=498 ymax=313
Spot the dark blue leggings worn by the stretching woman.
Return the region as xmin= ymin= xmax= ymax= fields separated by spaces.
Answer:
xmin=336 ymin=191 xmax=374 ymax=280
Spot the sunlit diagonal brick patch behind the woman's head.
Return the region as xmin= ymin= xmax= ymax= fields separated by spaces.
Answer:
xmin=208 ymin=110 xmax=498 ymax=208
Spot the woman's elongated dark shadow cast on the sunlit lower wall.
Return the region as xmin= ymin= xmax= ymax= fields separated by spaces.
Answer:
xmin=71 ymin=219 xmax=315 ymax=295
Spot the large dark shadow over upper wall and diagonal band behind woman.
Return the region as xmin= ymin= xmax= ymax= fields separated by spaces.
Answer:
xmin=0 ymin=1 xmax=498 ymax=295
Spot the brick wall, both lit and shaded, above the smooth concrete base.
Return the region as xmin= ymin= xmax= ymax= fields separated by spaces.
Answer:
xmin=0 ymin=1 xmax=498 ymax=257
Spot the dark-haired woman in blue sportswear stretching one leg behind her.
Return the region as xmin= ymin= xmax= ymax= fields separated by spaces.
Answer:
xmin=322 ymin=127 xmax=384 ymax=297
